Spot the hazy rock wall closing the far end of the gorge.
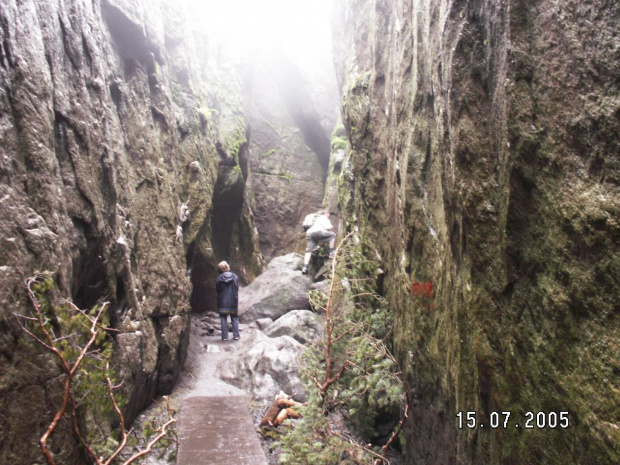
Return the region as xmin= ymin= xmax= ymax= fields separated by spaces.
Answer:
xmin=247 ymin=46 xmax=338 ymax=259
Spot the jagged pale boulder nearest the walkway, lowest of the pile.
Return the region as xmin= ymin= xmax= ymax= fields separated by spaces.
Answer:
xmin=218 ymin=336 xmax=305 ymax=402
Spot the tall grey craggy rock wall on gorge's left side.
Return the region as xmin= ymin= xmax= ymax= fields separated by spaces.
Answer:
xmin=0 ymin=0 xmax=261 ymax=464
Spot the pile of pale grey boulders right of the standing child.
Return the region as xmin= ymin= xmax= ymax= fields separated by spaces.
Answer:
xmin=218 ymin=253 xmax=323 ymax=402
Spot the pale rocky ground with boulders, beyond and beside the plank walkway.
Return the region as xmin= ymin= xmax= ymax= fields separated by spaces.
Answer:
xmin=134 ymin=254 xmax=314 ymax=465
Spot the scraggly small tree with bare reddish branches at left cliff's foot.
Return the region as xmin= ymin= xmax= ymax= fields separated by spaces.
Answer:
xmin=15 ymin=273 xmax=176 ymax=465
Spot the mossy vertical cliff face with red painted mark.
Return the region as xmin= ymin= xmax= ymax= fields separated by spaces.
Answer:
xmin=335 ymin=0 xmax=620 ymax=464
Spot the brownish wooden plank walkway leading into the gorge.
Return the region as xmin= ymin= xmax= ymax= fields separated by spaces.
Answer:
xmin=177 ymin=396 xmax=267 ymax=465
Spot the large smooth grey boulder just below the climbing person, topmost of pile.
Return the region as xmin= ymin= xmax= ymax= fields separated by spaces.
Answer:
xmin=239 ymin=257 xmax=310 ymax=323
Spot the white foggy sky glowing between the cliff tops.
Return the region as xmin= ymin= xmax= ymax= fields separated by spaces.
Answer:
xmin=187 ymin=0 xmax=333 ymax=58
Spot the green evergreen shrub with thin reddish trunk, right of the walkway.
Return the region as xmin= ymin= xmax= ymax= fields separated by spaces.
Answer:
xmin=280 ymin=234 xmax=408 ymax=465
